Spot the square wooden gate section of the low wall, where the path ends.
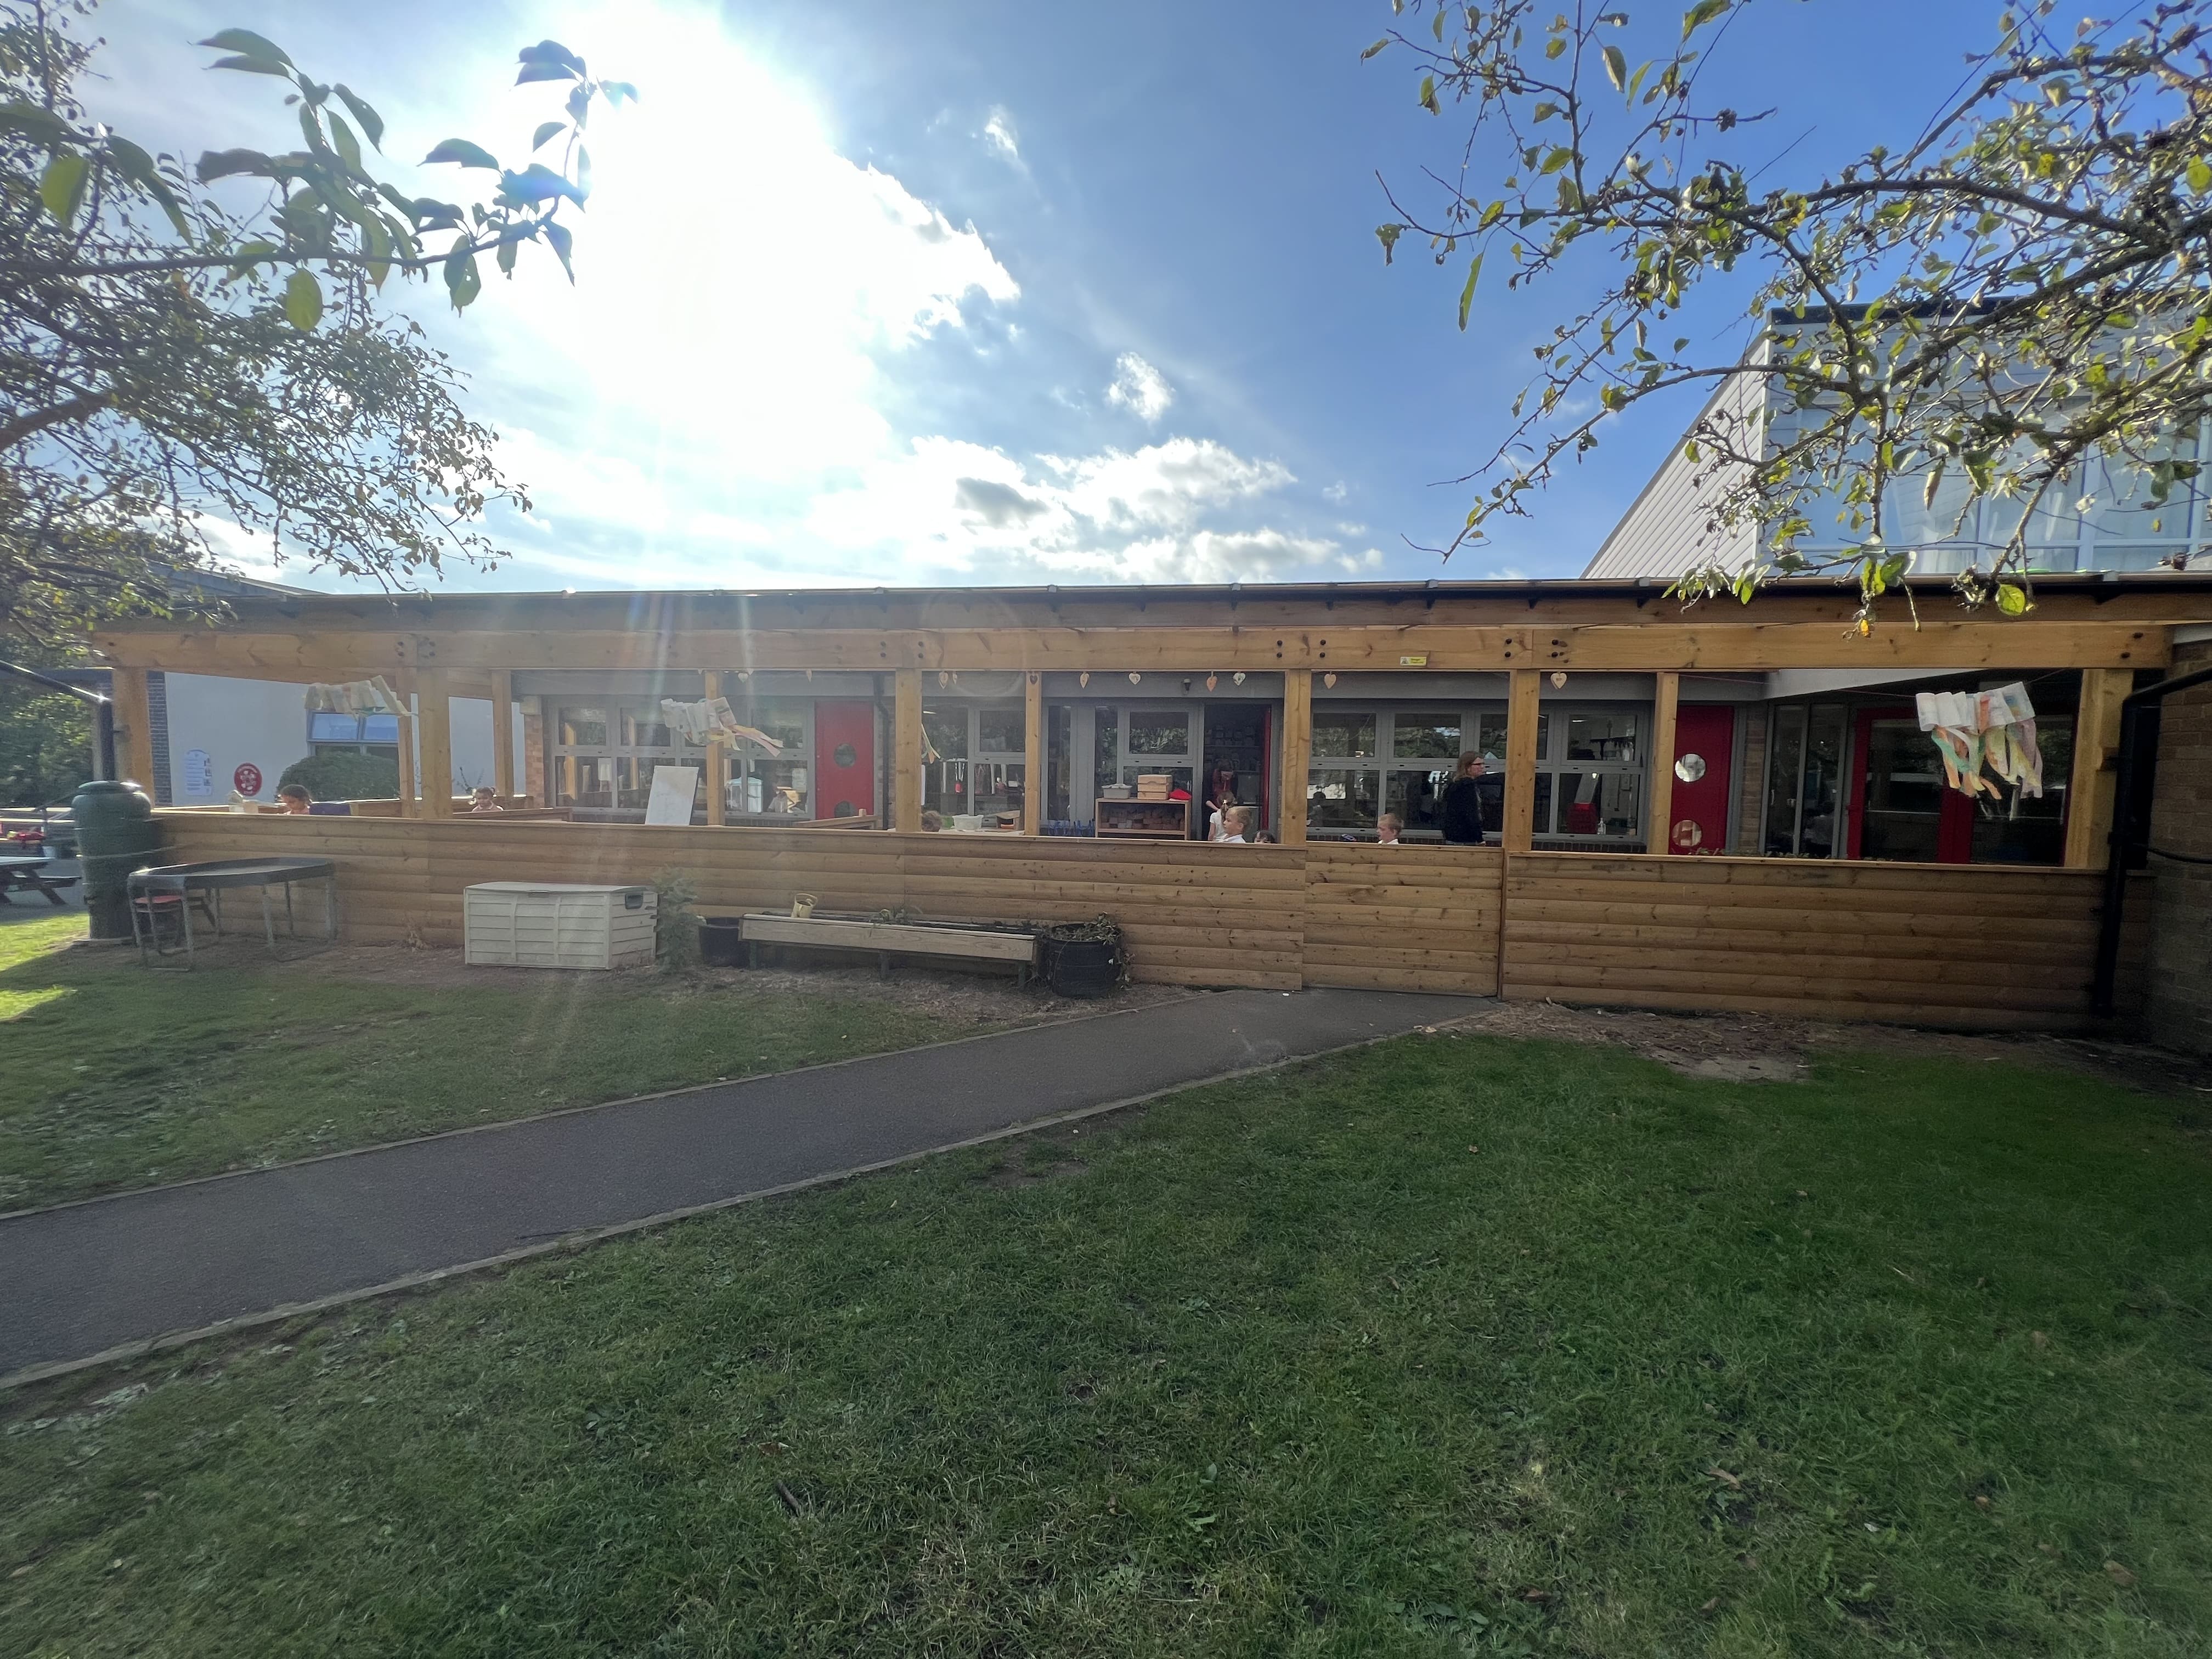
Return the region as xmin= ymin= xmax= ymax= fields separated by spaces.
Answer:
xmin=1305 ymin=840 xmax=1504 ymax=995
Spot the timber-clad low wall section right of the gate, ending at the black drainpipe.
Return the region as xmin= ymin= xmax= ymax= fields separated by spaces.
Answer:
xmin=1504 ymin=854 xmax=2132 ymax=1029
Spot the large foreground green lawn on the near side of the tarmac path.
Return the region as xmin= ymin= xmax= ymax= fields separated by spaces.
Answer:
xmin=0 ymin=1037 xmax=2212 ymax=1659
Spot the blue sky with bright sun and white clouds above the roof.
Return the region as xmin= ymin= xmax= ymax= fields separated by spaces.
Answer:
xmin=91 ymin=0 xmax=1997 ymax=589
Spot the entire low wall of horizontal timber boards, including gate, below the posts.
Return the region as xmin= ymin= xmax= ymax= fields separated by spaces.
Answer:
xmin=161 ymin=812 xmax=2143 ymax=1029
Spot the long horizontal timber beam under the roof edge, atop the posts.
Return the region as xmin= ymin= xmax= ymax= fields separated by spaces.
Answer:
xmin=97 ymin=619 xmax=2168 ymax=684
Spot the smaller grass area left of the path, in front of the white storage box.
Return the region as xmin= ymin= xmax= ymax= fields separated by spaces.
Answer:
xmin=0 ymin=913 xmax=973 ymax=1210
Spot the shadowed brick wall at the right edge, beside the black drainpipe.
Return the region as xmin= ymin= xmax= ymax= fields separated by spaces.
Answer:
xmin=2146 ymin=641 xmax=2212 ymax=1053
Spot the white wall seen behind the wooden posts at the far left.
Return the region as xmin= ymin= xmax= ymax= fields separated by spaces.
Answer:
xmin=161 ymin=675 xmax=522 ymax=808
